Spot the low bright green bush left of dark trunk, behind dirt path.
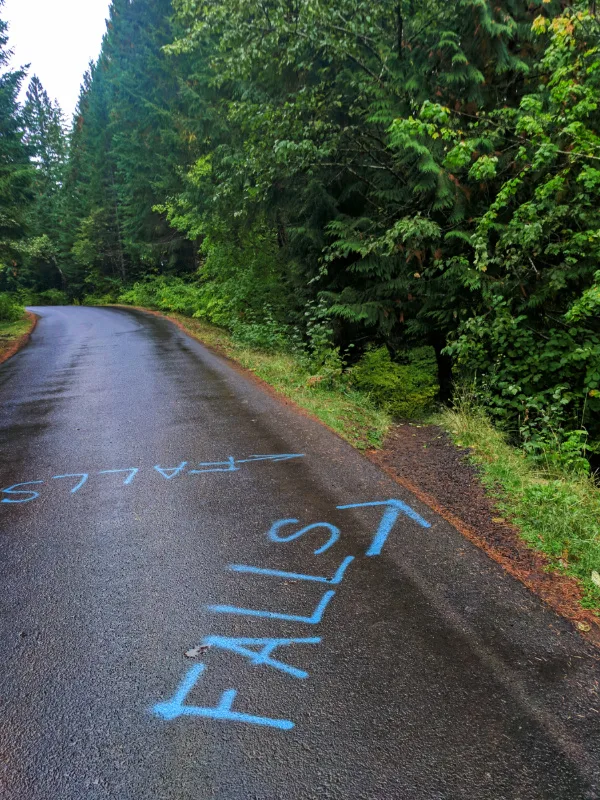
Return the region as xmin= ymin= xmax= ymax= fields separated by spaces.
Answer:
xmin=349 ymin=347 xmax=438 ymax=419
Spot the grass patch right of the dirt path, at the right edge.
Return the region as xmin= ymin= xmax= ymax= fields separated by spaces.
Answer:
xmin=436 ymin=405 xmax=600 ymax=613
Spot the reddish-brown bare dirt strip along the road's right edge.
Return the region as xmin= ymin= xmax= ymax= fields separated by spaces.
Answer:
xmin=117 ymin=304 xmax=600 ymax=647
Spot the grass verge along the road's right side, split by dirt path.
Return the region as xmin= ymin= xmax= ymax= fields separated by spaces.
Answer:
xmin=117 ymin=309 xmax=600 ymax=616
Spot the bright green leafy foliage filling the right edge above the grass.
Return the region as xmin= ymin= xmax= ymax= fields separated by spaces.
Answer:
xmin=424 ymin=4 xmax=600 ymax=456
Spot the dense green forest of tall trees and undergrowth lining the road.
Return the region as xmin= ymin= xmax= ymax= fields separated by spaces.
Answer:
xmin=0 ymin=0 xmax=600 ymax=469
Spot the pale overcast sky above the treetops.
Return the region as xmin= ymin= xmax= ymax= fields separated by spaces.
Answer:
xmin=0 ymin=0 xmax=110 ymax=121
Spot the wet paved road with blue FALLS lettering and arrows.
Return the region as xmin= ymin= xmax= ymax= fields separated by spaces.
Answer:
xmin=0 ymin=308 xmax=600 ymax=800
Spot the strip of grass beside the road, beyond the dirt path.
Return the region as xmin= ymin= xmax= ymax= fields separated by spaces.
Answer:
xmin=169 ymin=314 xmax=391 ymax=449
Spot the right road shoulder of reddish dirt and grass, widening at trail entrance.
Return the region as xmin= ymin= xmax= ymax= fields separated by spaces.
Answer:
xmin=110 ymin=306 xmax=600 ymax=646
